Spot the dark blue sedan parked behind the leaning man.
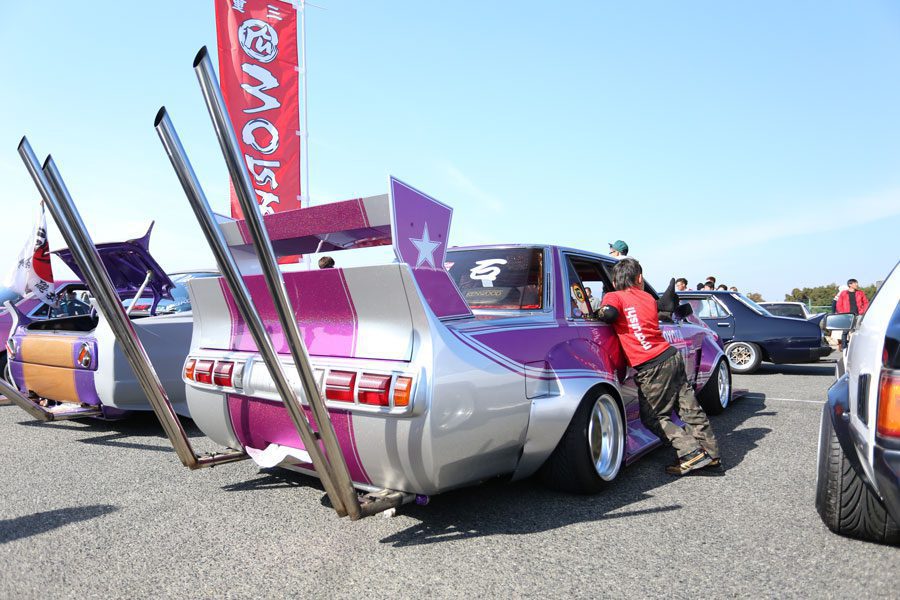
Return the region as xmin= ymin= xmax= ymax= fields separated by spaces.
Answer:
xmin=678 ymin=291 xmax=831 ymax=374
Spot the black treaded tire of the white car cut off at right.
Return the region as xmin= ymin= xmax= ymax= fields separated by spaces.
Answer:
xmin=816 ymin=404 xmax=900 ymax=546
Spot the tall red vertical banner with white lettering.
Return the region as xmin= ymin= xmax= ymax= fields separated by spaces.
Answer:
xmin=216 ymin=0 xmax=301 ymax=218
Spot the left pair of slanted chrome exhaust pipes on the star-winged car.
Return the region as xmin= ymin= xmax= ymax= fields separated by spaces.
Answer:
xmin=17 ymin=137 xmax=247 ymax=469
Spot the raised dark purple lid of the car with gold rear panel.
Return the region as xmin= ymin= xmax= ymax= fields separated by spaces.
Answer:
xmin=53 ymin=223 xmax=175 ymax=306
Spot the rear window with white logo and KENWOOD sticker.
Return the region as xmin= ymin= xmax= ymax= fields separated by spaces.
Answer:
xmin=444 ymin=248 xmax=544 ymax=310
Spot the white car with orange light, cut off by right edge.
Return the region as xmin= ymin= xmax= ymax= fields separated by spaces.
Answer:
xmin=816 ymin=265 xmax=900 ymax=545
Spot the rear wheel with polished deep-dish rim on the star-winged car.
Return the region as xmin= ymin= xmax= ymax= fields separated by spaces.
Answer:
xmin=539 ymin=391 xmax=625 ymax=494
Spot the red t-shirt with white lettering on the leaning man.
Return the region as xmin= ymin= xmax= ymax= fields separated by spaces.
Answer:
xmin=601 ymin=287 xmax=669 ymax=366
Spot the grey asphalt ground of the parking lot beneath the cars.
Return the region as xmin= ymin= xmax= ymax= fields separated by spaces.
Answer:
xmin=0 ymin=356 xmax=900 ymax=598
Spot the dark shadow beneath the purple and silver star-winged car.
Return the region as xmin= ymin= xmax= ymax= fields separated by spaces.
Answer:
xmin=216 ymin=394 xmax=775 ymax=547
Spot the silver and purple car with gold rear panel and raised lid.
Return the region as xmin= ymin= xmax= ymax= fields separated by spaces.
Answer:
xmin=6 ymin=227 xmax=217 ymax=419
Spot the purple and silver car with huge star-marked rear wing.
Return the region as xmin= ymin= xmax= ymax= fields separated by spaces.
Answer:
xmin=176 ymin=180 xmax=731 ymax=502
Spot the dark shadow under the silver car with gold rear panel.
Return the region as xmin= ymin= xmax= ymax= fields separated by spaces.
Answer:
xmin=16 ymin=407 xmax=206 ymax=452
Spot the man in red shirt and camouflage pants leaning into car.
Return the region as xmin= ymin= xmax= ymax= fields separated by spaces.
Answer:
xmin=599 ymin=258 xmax=721 ymax=475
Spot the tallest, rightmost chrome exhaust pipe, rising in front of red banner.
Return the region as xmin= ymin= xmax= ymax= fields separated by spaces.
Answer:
xmin=194 ymin=46 xmax=360 ymax=520
